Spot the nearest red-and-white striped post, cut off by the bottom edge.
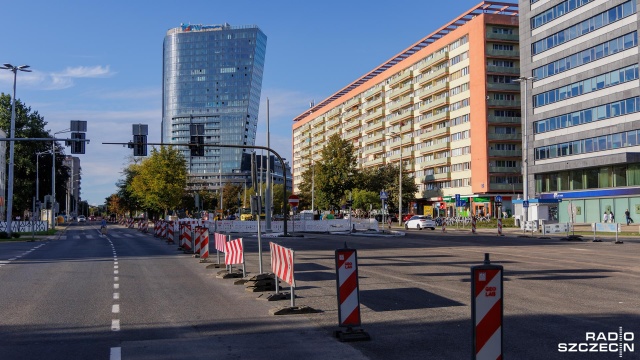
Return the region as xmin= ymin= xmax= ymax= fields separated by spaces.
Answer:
xmin=471 ymin=254 xmax=503 ymax=360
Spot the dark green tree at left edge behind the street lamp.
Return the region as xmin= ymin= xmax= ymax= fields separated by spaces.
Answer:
xmin=0 ymin=93 xmax=70 ymax=215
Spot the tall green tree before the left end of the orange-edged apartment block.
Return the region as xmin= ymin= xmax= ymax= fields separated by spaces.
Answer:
xmin=312 ymin=134 xmax=358 ymax=209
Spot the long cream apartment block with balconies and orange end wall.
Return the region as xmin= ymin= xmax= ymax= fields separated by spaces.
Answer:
xmin=293 ymin=1 xmax=522 ymax=215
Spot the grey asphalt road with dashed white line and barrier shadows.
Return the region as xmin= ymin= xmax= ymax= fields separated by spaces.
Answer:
xmin=0 ymin=224 xmax=640 ymax=359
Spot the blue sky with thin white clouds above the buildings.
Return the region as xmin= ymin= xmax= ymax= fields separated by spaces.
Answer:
xmin=0 ymin=0 xmax=492 ymax=205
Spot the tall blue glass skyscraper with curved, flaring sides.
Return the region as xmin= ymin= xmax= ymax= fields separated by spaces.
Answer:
xmin=161 ymin=24 xmax=267 ymax=190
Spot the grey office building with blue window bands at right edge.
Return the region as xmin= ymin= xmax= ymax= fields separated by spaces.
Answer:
xmin=519 ymin=0 xmax=640 ymax=223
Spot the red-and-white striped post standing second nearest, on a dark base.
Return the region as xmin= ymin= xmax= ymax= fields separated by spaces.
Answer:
xmin=336 ymin=249 xmax=360 ymax=327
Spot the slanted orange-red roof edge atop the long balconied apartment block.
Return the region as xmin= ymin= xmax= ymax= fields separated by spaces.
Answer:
xmin=293 ymin=1 xmax=518 ymax=122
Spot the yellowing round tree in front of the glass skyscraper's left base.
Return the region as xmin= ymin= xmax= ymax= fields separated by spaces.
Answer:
xmin=131 ymin=146 xmax=187 ymax=216
